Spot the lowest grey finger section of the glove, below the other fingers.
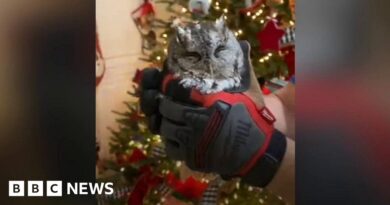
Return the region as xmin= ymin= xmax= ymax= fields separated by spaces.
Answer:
xmin=161 ymin=118 xmax=191 ymax=160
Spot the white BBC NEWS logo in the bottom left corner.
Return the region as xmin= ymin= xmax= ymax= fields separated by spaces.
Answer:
xmin=8 ymin=180 xmax=114 ymax=197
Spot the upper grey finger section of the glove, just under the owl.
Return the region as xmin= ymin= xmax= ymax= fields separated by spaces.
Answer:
xmin=159 ymin=98 xmax=207 ymax=123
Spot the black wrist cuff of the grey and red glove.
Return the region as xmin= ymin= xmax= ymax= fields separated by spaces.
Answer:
xmin=241 ymin=129 xmax=287 ymax=187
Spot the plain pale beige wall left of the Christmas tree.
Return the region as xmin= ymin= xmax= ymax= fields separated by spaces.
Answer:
xmin=96 ymin=0 xmax=146 ymax=158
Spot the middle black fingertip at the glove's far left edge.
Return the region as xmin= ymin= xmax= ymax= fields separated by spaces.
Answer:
xmin=140 ymin=90 xmax=160 ymax=116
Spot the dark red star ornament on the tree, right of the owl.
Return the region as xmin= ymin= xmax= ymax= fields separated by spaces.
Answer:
xmin=257 ymin=20 xmax=285 ymax=53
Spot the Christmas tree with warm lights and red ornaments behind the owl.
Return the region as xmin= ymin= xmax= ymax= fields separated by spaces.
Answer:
xmin=99 ymin=0 xmax=294 ymax=205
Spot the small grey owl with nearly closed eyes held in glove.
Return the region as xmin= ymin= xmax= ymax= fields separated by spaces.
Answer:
xmin=167 ymin=18 xmax=244 ymax=94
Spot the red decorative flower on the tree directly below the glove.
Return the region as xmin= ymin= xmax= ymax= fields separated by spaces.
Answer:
xmin=166 ymin=173 xmax=207 ymax=199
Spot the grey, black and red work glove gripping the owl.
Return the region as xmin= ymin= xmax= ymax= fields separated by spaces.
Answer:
xmin=141 ymin=40 xmax=286 ymax=187
